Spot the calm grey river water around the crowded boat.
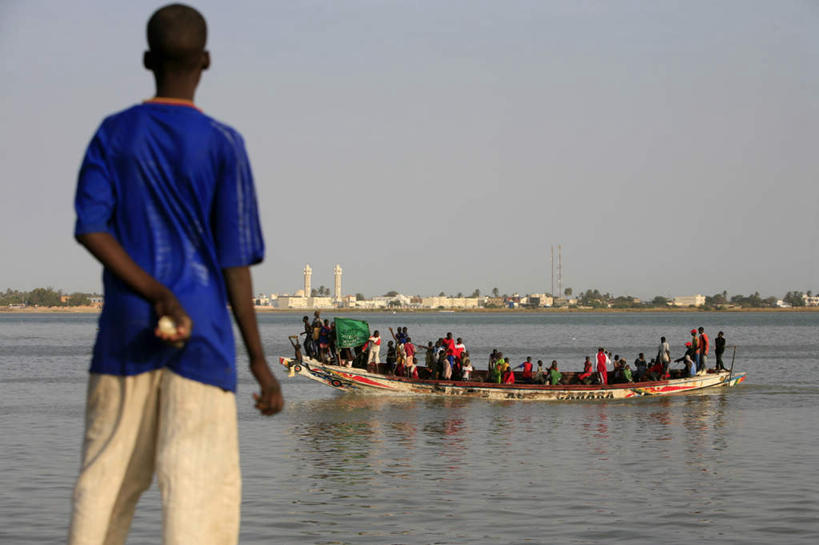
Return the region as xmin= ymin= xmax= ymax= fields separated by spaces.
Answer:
xmin=0 ymin=313 xmax=819 ymax=545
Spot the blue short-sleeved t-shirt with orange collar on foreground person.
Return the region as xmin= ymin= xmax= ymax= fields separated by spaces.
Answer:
xmin=74 ymin=100 xmax=264 ymax=391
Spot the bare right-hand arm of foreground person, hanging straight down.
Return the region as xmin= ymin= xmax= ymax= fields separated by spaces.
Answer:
xmin=223 ymin=267 xmax=284 ymax=416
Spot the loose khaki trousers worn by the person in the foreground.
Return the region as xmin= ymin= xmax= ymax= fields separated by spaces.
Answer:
xmin=68 ymin=369 xmax=241 ymax=545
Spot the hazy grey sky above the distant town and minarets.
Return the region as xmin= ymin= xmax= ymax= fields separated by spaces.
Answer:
xmin=0 ymin=0 xmax=819 ymax=297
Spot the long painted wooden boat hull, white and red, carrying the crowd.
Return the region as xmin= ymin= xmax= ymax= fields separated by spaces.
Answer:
xmin=279 ymin=357 xmax=745 ymax=401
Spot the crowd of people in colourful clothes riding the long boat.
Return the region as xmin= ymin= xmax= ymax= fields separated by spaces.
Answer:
xmin=294 ymin=311 xmax=726 ymax=386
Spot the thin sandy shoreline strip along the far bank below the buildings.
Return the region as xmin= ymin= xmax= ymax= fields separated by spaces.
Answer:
xmin=0 ymin=306 xmax=819 ymax=314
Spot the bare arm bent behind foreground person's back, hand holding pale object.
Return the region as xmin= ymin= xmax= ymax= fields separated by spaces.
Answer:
xmin=77 ymin=233 xmax=193 ymax=343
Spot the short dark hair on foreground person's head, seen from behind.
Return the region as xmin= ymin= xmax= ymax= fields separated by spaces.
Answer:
xmin=147 ymin=4 xmax=208 ymax=69
